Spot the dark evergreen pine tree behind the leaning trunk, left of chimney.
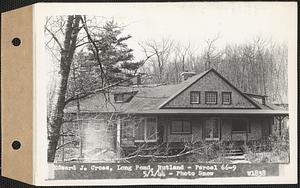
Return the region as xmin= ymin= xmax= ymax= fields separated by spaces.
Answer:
xmin=67 ymin=21 xmax=143 ymax=104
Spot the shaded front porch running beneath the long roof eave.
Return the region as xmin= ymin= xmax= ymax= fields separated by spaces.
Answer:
xmin=120 ymin=114 xmax=286 ymax=148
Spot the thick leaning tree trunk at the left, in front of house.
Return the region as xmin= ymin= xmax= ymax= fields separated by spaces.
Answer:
xmin=48 ymin=16 xmax=80 ymax=162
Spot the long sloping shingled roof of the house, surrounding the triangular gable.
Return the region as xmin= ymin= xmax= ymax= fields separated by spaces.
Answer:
xmin=65 ymin=69 xmax=288 ymax=114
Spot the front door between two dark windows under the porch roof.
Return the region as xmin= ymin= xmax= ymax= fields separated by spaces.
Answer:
xmin=204 ymin=119 xmax=220 ymax=140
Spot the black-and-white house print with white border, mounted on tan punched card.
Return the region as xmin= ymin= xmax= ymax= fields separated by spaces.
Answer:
xmin=37 ymin=2 xmax=297 ymax=184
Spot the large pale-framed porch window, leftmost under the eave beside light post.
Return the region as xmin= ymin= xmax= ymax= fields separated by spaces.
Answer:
xmin=135 ymin=117 xmax=157 ymax=142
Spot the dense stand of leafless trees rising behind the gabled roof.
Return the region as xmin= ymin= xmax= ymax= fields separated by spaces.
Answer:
xmin=142 ymin=36 xmax=287 ymax=103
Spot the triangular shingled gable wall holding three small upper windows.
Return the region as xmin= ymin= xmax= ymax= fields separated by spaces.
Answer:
xmin=159 ymin=69 xmax=260 ymax=109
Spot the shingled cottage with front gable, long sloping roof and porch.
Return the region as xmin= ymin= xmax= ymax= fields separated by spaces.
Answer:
xmin=66 ymin=69 xmax=288 ymax=161
